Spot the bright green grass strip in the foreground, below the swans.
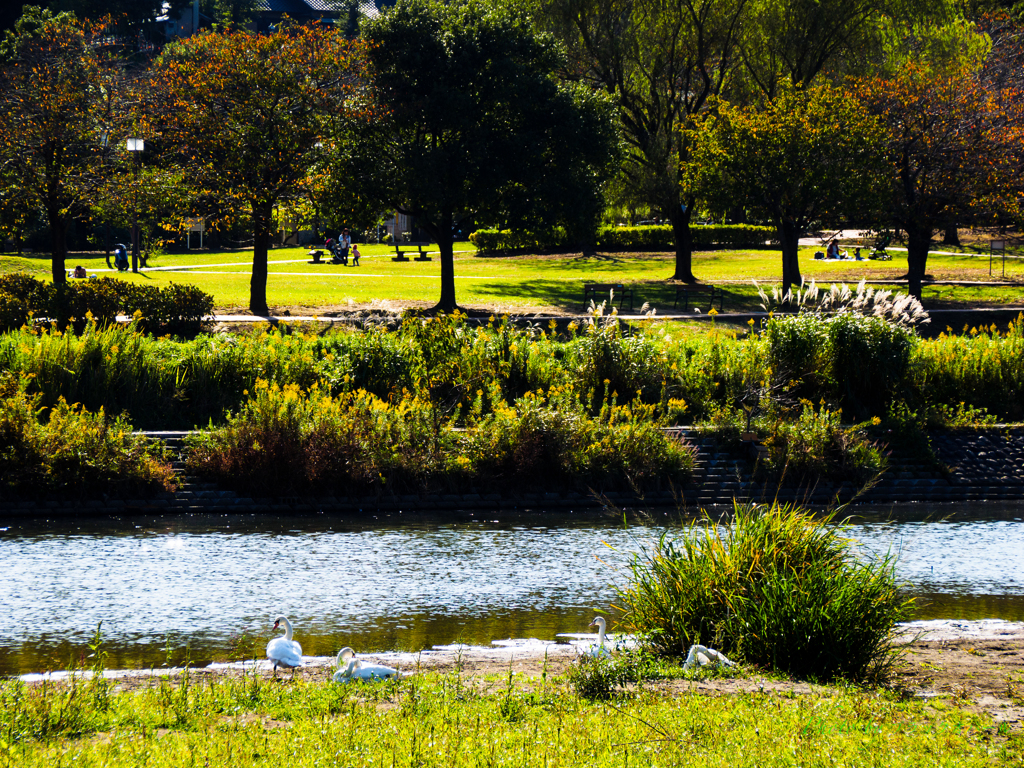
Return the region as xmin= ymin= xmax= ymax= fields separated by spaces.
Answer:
xmin=0 ymin=673 xmax=1024 ymax=766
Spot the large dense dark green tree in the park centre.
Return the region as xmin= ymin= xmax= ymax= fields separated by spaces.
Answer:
xmin=338 ymin=0 xmax=617 ymax=311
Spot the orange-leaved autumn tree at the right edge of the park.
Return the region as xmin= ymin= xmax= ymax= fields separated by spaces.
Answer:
xmin=856 ymin=14 xmax=1024 ymax=298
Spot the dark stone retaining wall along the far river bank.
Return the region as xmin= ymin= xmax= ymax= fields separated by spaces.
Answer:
xmin=6 ymin=426 xmax=1024 ymax=517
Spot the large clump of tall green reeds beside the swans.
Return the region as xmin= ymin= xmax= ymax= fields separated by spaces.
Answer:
xmin=618 ymin=504 xmax=911 ymax=680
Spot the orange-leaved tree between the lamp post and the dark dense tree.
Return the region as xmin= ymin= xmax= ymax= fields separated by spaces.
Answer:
xmin=148 ymin=25 xmax=365 ymax=314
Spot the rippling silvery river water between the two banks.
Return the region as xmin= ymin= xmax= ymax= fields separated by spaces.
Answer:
xmin=0 ymin=505 xmax=1024 ymax=675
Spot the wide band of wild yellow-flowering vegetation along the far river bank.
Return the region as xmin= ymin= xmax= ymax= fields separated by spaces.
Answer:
xmin=0 ymin=288 xmax=1024 ymax=497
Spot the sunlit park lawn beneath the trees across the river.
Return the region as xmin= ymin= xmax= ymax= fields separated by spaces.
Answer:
xmin=0 ymin=243 xmax=1024 ymax=314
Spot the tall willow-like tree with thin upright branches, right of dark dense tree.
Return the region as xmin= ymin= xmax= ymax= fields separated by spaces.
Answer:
xmin=540 ymin=0 xmax=748 ymax=282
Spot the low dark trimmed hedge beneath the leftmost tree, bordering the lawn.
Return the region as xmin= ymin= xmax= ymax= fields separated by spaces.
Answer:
xmin=0 ymin=273 xmax=213 ymax=336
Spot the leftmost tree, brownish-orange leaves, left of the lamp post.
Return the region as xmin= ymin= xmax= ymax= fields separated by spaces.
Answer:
xmin=0 ymin=6 xmax=127 ymax=283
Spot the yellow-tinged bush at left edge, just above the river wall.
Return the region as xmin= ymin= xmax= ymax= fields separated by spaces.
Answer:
xmin=0 ymin=372 xmax=173 ymax=499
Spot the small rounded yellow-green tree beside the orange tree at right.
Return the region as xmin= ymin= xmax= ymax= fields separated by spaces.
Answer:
xmin=690 ymin=85 xmax=884 ymax=292
